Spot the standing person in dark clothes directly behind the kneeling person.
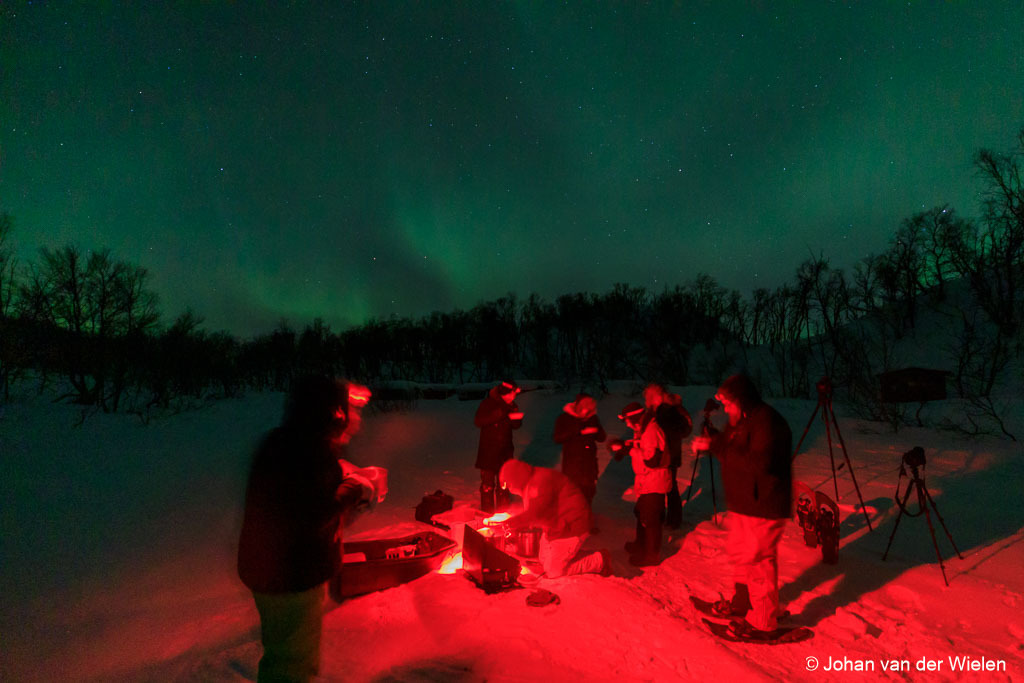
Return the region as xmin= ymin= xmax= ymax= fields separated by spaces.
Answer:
xmin=473 ymin=381 xmax=522 ymax=512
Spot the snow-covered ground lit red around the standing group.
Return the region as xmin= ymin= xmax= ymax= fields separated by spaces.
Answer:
xmin=0 ymin=387 xmax=1024 ymax=681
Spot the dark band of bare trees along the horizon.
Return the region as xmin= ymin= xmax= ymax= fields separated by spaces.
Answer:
xmin=0 ymin=130 xmax=1024 ymax=431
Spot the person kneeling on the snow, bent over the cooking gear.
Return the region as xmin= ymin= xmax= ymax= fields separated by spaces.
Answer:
xmin=499 ymin=460 xmax=611 ymax=579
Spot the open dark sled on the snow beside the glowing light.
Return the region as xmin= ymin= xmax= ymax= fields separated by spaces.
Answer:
xmin=328 ymin=531 xmax=456 ymax=602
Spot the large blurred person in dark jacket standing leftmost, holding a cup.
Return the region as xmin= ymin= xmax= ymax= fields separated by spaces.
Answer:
xmin=239 ymin=377 xmax=387 ymax=681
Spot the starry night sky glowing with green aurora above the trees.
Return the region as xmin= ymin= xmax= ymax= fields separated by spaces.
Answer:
xmin=0 ymin=0 xmax=1024 ymax=335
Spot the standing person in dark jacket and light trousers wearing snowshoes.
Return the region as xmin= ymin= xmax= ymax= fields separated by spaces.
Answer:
xmin=691 ymin=375 xmax=793 ymax=636
